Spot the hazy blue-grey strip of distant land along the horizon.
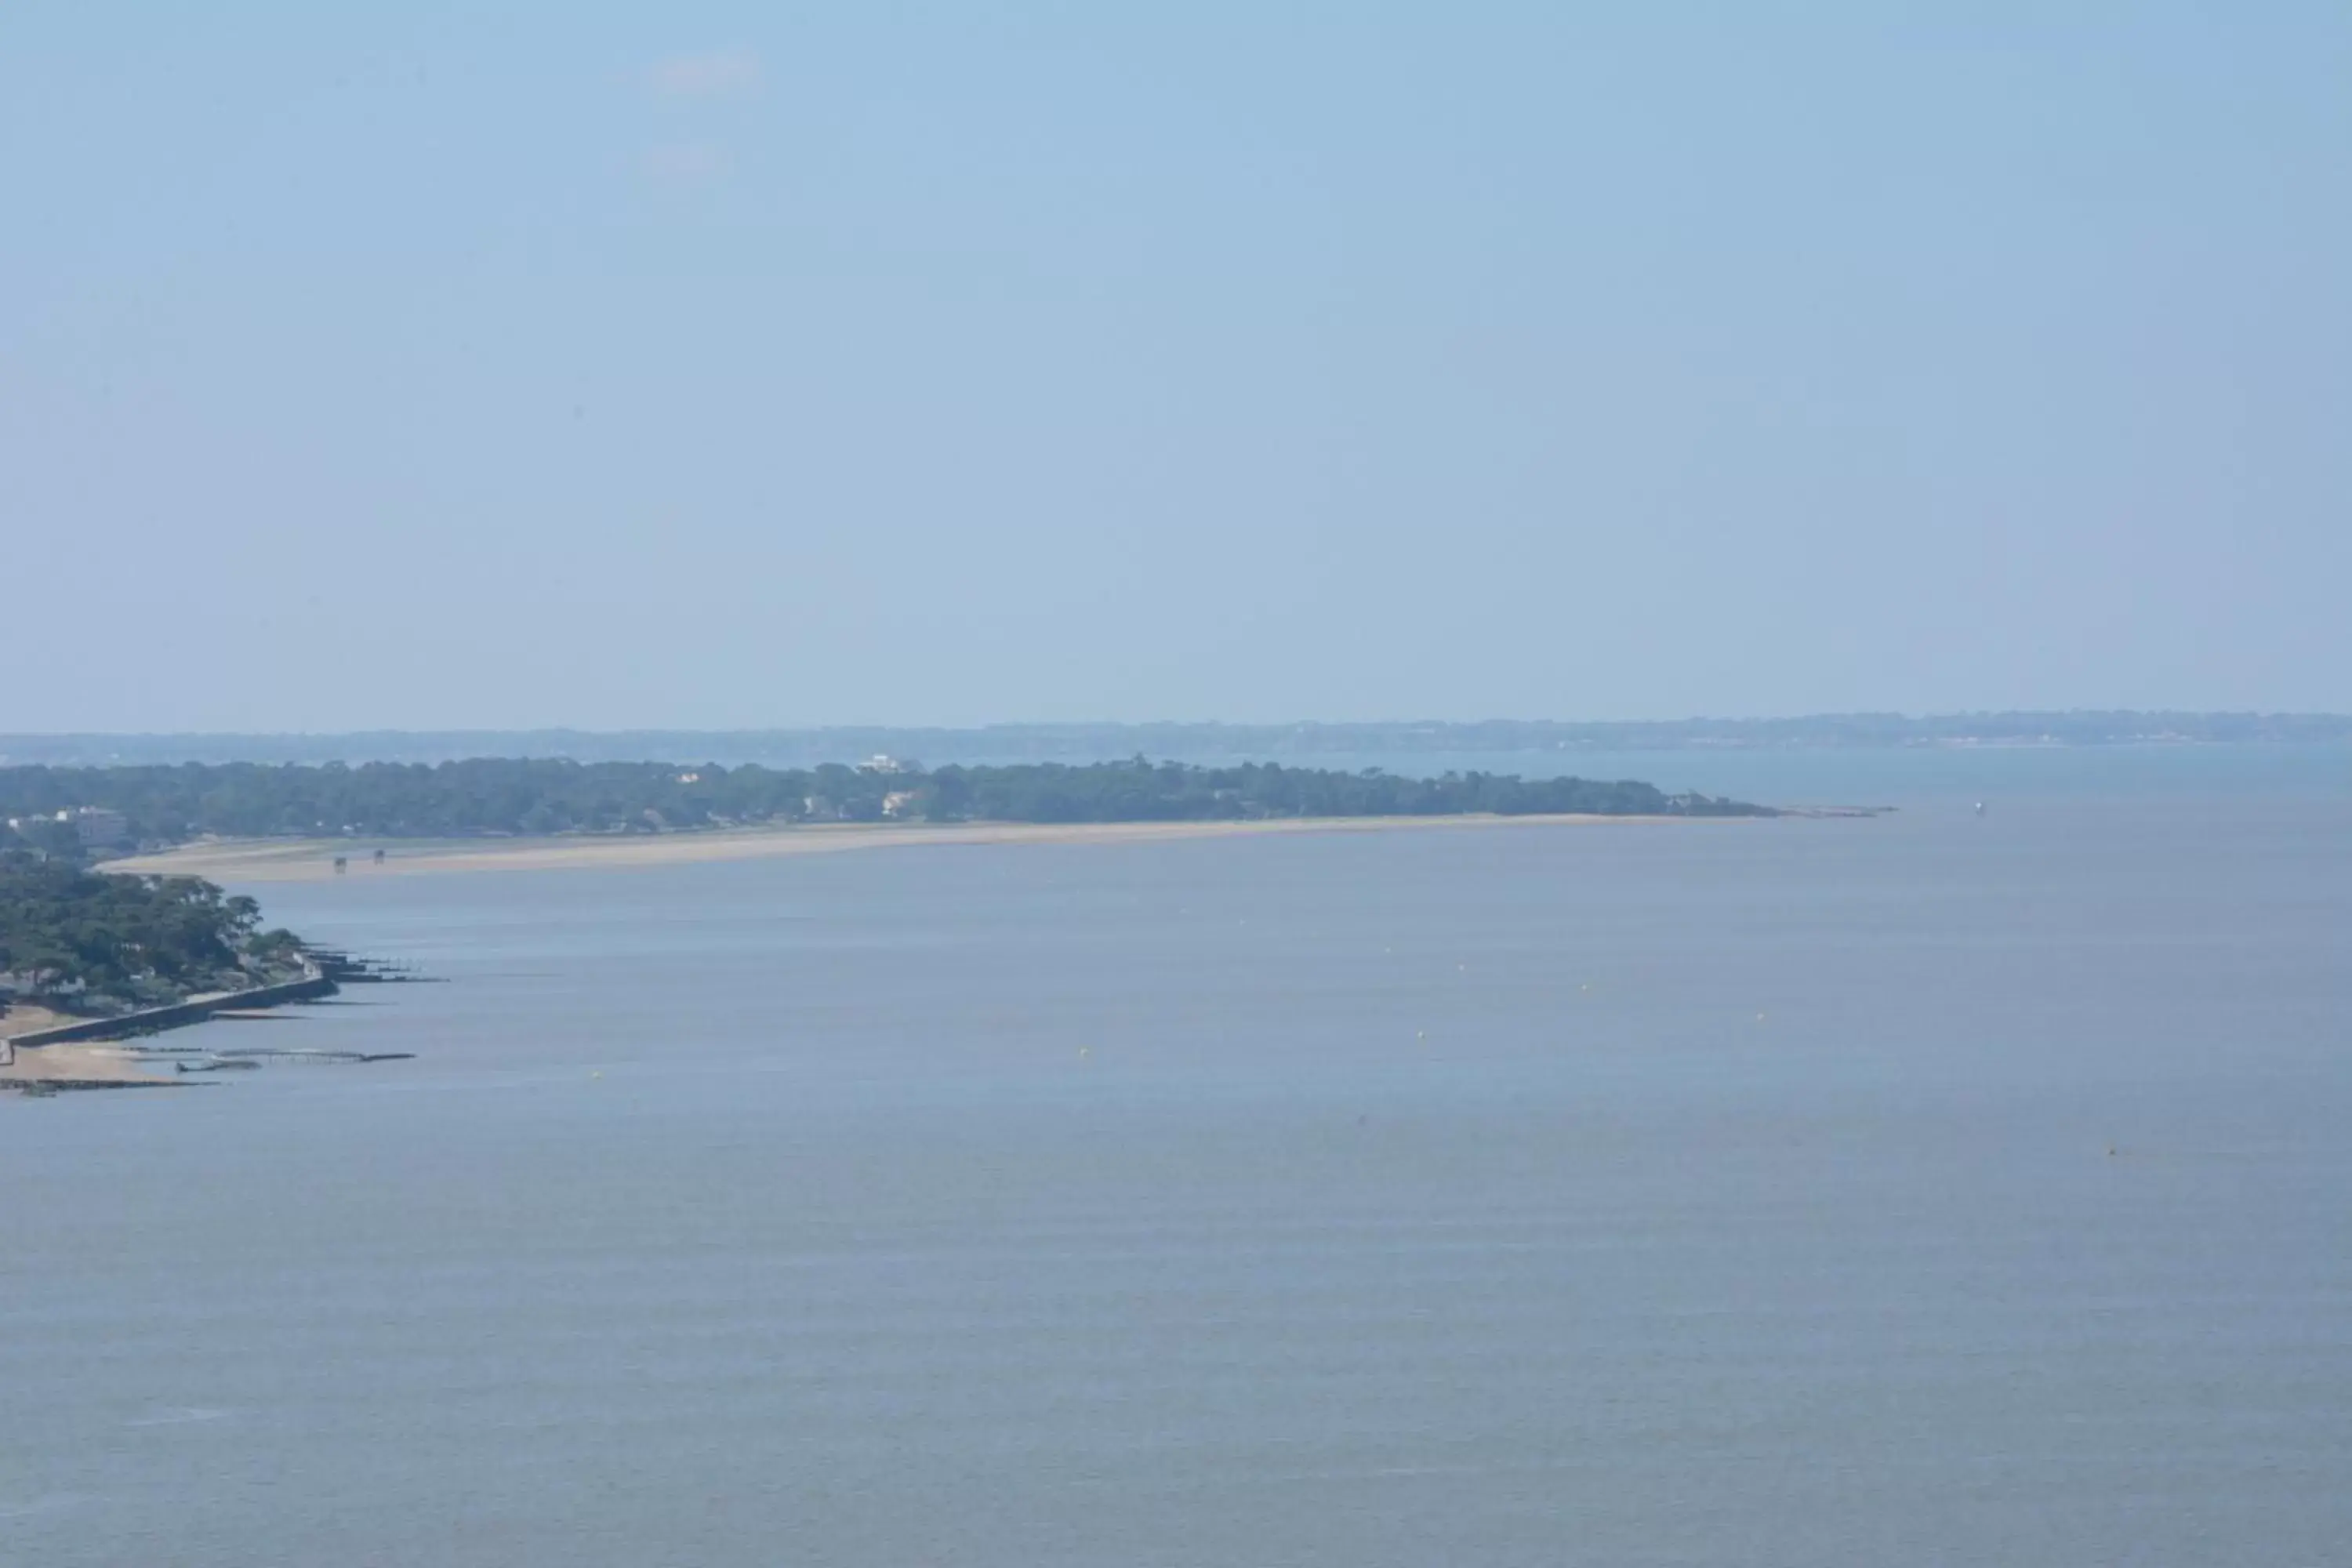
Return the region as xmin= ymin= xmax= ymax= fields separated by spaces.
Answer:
xmin=0 ymin=710 xmax=2352 ymax=767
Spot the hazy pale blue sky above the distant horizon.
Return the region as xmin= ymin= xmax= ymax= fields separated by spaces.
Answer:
xmin=0 ymin=0 xmax=2352 ymax=731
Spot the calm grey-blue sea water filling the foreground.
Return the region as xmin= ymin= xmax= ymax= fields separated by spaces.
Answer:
xmin=0 ymin=764 xmax=2352 ymax=1568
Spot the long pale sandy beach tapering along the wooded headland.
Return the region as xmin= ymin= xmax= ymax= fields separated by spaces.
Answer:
xmin=103 ymin=815 xmax=1731 ymax=881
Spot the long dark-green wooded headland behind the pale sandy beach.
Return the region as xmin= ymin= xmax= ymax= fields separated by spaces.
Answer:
xmin=0 ymin=757 xmax=1776 ymax=853
